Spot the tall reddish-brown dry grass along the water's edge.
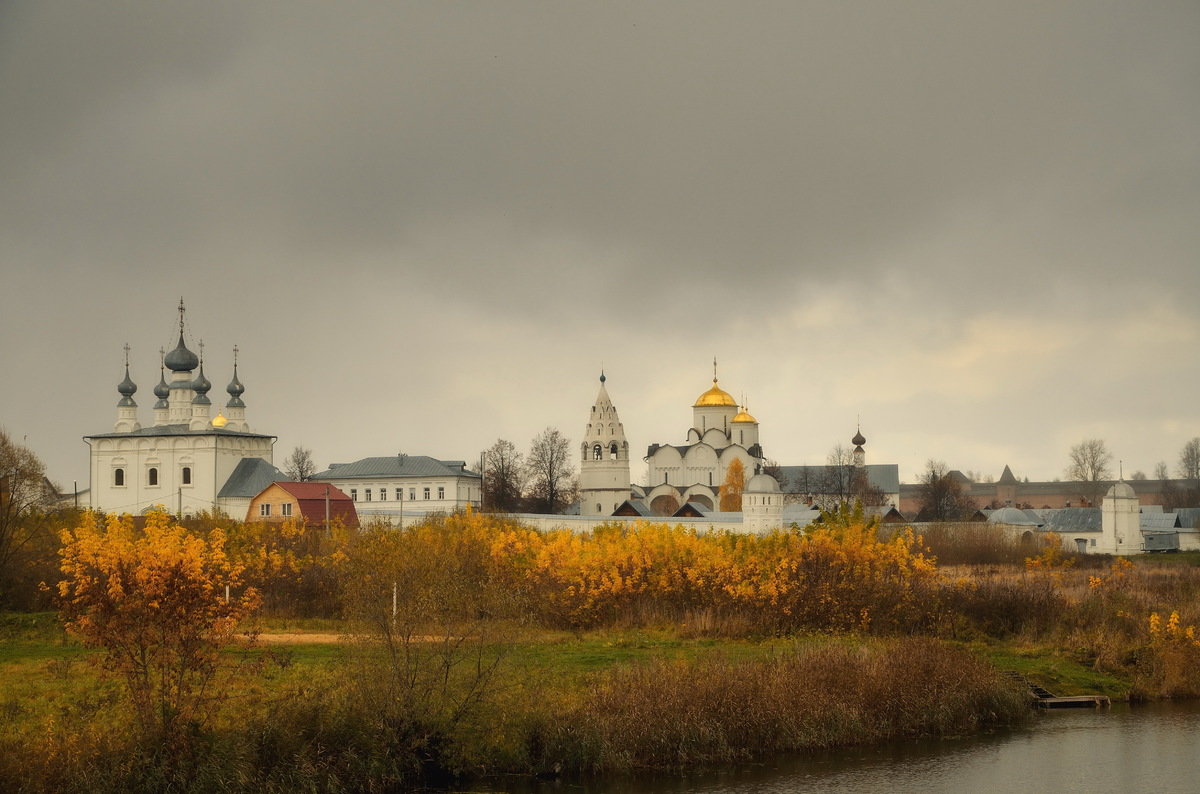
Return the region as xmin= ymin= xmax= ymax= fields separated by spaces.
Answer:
xmin=532 ymin=638 xmax=1028 ymax=771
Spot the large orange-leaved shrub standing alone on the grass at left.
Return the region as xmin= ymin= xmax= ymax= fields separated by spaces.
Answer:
xmin=58 ymin=512 xmax=259 ymax=745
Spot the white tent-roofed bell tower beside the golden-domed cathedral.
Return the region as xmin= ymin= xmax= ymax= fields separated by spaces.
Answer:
xmin=580 ymin=372 xmax=630 ymax=516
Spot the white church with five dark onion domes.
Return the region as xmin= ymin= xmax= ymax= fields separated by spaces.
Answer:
xmin=84 ymin=301 xmax=284 ymax=517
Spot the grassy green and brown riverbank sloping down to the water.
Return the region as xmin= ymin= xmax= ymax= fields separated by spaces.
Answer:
xmin=0 ymin=616 xmax=1056 ymax=792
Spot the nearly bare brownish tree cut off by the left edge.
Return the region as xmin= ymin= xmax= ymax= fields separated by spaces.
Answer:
xmin=0 ymin=429 xmax=54 ymax=601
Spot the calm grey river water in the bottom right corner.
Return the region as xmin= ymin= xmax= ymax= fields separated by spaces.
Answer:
xmin=475 ymin=703 xmax=1200 ymax=794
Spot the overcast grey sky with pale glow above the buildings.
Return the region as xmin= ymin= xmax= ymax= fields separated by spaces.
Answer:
xmin=0 ymin=0 xmax=1200 ymax=488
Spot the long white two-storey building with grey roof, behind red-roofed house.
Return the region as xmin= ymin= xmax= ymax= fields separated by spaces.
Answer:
xmin=312 ymin=455 xmax=482 ymax=524
